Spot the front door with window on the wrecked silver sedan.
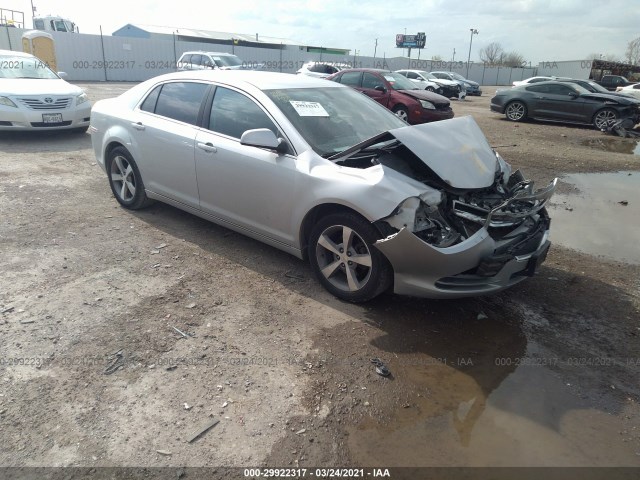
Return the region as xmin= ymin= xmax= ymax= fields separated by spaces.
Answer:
xmin=195 ymin=87 xmax=298 ymax=245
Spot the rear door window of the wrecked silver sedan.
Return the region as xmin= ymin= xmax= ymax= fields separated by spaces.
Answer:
xmin=152 ymin=82 xmax=207 ymax=125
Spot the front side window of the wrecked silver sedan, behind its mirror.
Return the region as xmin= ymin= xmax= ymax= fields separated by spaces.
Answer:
xmin=208 ymin=87 xmax=278 ymax=139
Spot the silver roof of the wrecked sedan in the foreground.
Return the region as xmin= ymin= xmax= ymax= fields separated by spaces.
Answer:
xmin=146 ymin=70 xmax=348 ymax=90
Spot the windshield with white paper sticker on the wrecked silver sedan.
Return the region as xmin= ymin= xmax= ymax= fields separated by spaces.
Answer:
xmin=265 ymin=84 xmax=407 ymax=157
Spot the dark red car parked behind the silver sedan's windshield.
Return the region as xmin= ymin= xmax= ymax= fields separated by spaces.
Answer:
xmin=327 ymin=68 xmax=453 ymax=124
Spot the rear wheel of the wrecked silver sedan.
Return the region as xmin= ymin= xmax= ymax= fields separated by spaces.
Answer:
xmin=106 ymin=147 xmax=152 ymax=210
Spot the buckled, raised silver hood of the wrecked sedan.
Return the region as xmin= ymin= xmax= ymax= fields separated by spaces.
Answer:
xmin=389 ymin=116 xmax=498 ymax=189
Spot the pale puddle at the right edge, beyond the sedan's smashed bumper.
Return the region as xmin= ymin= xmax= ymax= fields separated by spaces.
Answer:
xmin=549 ymin=172 xmax=640 ymax=264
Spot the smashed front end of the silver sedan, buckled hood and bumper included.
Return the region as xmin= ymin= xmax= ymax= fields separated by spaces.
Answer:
xmin=330 ymin=118 xmax=557 ymax=298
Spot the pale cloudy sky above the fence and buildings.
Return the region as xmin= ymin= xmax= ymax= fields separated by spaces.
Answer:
xmin=0 ymin=0 xmax=640 ymax=64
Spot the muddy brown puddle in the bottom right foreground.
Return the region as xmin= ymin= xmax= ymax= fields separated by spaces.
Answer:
xmin=348 ymin=350 xmax=640 ymax=467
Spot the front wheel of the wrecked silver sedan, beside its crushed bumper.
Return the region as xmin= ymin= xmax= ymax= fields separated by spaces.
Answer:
xmin=307 ymin=213 xmax=393 ymax=303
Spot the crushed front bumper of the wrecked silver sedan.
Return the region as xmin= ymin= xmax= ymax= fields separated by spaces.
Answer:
xmin=375 ymin=179 xmax=557 ymax=298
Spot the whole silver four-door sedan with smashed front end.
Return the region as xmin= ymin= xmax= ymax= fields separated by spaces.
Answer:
xmin=90 ymin=71 xmax=555 ymax=302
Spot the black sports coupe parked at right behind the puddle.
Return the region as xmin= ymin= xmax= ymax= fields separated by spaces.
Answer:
xmin=491 ymin=81 xmax=640 ymax=130
